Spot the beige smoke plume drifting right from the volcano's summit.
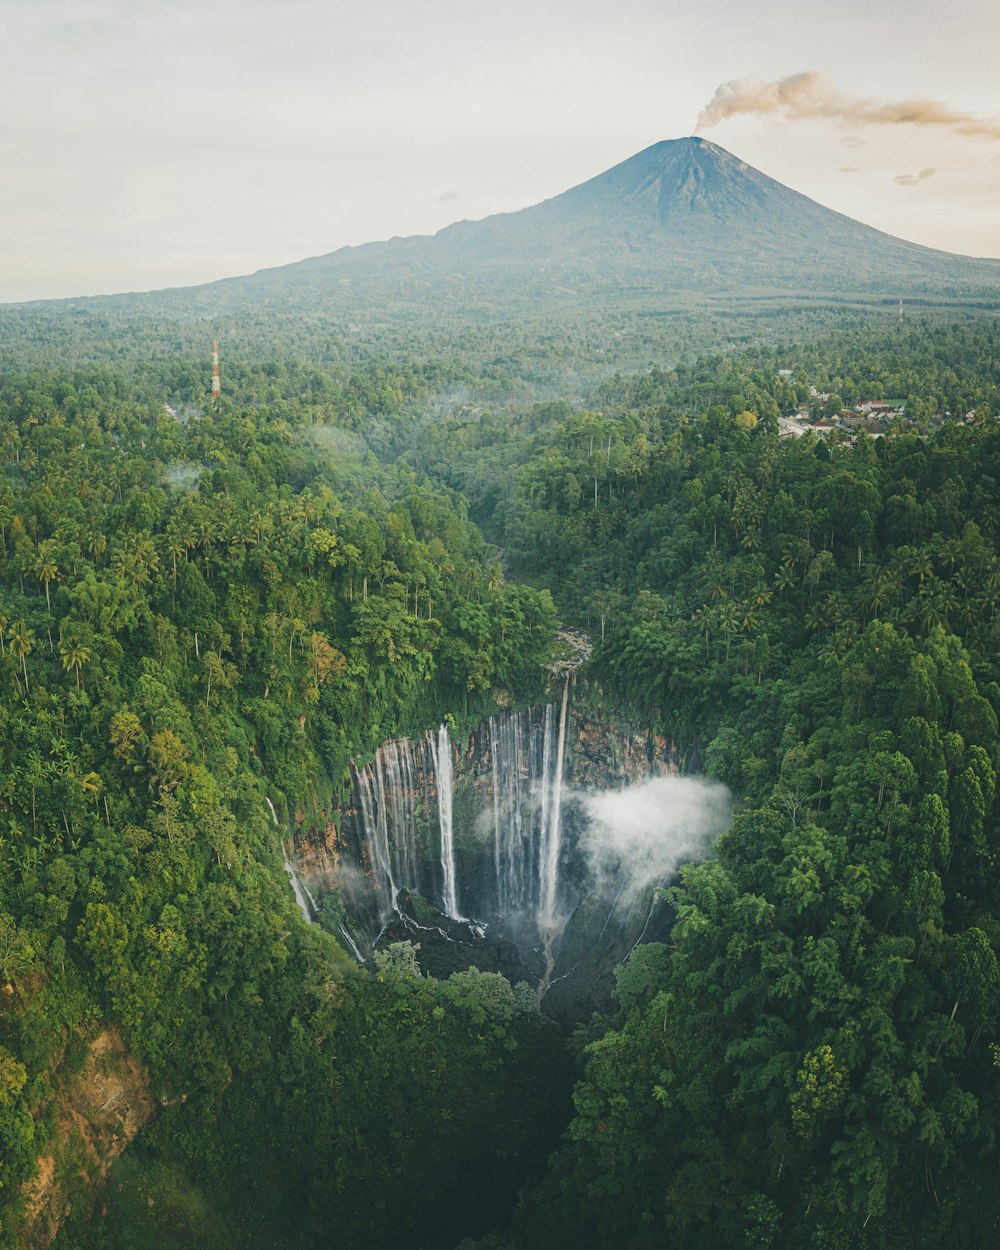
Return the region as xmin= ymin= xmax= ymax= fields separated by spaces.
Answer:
xmin=698 ymin=70 xmax=1000 ymax=140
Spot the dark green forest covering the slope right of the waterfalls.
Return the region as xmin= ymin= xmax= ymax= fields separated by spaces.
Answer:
xmin=432 ymin=326 xmax=1000 ymax=1250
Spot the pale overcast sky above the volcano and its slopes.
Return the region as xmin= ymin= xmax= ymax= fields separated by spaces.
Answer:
xmin=0 ymin=0 xmax=1000 ymax=301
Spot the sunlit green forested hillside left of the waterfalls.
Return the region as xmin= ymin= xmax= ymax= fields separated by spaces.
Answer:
xmin=0 ymin=371 xmax=560 ymax=1246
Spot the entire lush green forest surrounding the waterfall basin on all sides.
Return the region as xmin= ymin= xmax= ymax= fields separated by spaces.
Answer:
xmin=0 ymin=319 xmax=1000 ymax=1250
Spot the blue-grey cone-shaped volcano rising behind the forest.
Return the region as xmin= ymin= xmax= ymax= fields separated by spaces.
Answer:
xmin=166 ymin=139 xmax=1000 ymax=308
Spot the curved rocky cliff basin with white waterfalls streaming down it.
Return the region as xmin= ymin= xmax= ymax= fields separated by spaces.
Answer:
xmin=281 ymin=705 xmax=715 ymax=1021
